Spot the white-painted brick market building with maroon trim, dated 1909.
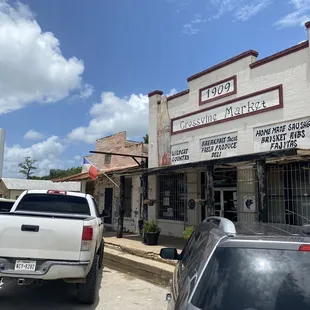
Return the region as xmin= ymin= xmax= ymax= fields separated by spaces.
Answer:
xmin=147 ymin=23 xmax=310 ymax=236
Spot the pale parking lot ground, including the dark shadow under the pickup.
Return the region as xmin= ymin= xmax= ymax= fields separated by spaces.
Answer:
xmin=0 ymin=268 xmax=168 ymax=310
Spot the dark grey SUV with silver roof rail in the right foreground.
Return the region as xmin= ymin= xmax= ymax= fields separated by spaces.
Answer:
xmin=160 ymin=217 xmax=310 ymax=310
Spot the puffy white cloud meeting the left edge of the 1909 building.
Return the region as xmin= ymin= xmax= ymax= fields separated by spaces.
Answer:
xmin=68 ymin=89 xmax=177 ymax=144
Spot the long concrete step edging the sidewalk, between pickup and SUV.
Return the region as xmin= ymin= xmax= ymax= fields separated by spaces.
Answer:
xmin=104 ymin=245 xmax=175 ymax=284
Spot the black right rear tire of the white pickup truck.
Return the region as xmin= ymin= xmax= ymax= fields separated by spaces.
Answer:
xmin=77 ymin=255 xmax=99 ymax=305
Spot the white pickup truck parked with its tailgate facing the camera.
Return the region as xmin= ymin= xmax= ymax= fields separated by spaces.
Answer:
xmin=0 ymin=190 xmax=104 ymax=304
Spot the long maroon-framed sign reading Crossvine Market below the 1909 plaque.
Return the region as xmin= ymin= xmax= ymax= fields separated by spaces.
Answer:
xmin=171 ymin=85 xmax=283 ymax=134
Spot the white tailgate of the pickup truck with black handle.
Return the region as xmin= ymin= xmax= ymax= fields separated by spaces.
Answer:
xmin=0 ymin=214 xmax=83 ymax=261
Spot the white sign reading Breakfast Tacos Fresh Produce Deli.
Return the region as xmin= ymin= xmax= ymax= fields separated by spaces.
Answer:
xmin=200 ymin=132 xmax=238 ymax=160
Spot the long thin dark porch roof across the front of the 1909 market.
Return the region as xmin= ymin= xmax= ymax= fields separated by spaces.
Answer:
xmin=115 ymin=148 xmax=310 ymax=175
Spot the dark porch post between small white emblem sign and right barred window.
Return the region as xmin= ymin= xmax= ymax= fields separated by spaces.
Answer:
xmin=256 ymin=159 xmax=268 ymax=223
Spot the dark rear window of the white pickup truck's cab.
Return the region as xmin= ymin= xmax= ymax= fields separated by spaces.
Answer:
xmin=16 ymin=194 xmax=90 ymax=215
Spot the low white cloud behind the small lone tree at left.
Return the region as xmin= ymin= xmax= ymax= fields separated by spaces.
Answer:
xmin=3 ymin=136 xmax=65 ymax=178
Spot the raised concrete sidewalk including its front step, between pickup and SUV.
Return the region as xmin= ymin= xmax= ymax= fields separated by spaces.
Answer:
xmin=104 ymin=231 xmax=186 ymax=280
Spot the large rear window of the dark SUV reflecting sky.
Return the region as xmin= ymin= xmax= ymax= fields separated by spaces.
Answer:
xmin=191 ymin=248 xmax=310 ymax=310
